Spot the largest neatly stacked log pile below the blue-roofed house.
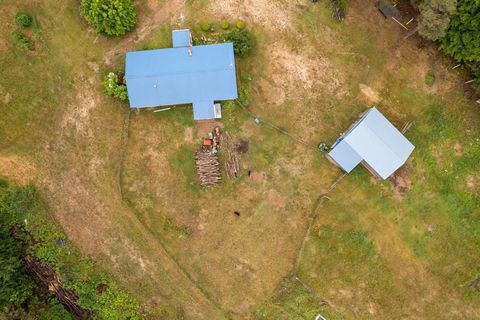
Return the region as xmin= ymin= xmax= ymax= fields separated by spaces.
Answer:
xmin=195 ymin=150 xmax=222 ymax=187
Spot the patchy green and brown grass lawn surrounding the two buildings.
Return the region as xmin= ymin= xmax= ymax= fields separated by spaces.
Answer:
xmin=0 ymin=0 xmax=480 ymax=319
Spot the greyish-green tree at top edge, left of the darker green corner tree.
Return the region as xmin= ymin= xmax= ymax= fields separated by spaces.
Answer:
xmin=418 ymin=0 xmax=457 ymax=41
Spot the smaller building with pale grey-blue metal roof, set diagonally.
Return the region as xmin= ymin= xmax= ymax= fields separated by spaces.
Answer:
xmin=328 ymin=107 xmax=415 ymax=179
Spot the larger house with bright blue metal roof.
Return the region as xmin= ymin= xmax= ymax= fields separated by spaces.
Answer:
xmin=125 ymin=29 xmax=238 ymax=120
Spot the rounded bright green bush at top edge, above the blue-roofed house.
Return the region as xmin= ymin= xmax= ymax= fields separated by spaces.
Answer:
xmin=81 ymin=0 xmax=137 ymax=36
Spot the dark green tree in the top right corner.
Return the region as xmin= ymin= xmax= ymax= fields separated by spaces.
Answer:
xmin=440 ymin=0 xmax=480 ymax=62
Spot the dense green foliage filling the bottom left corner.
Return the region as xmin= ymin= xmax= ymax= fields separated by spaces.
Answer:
xmin=0 ymin=180 xmax=144 ymax=320
